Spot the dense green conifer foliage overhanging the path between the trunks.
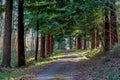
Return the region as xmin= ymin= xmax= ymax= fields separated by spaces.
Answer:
xmin=25 ymin=0 xmax=107 ymax=36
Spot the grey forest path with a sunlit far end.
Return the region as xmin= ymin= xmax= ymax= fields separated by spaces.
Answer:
xmin=35 ymin=51 xmax=81 ymax=80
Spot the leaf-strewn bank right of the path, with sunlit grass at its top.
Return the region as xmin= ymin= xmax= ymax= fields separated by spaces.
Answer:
xmin=76 ymin=43 xmax=120 ymax=80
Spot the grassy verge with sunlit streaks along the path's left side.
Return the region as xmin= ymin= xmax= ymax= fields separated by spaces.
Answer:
xmin=0 ymin=51 xmax=64 ymax=80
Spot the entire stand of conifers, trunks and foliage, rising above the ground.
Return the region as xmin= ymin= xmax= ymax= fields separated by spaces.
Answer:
xmin=0 ymin=0 xmax=120 ymax=66
